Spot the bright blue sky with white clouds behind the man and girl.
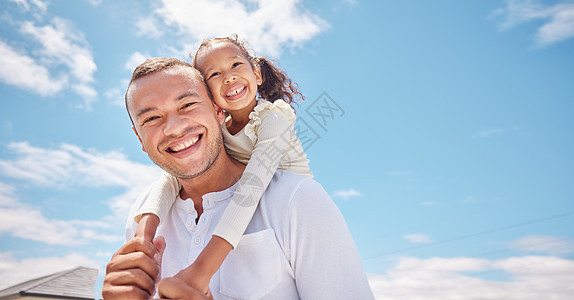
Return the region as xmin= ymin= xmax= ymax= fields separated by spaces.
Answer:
xmin=0 ymin=0 xmax=574 ymax=299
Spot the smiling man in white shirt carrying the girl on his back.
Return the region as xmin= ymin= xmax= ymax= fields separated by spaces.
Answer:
xmin=102 ymin=58 xmax=373 ymax=299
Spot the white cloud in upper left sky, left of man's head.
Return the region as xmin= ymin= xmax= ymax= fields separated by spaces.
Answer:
xmin=0 ymin=0 xmax=98 ymax=110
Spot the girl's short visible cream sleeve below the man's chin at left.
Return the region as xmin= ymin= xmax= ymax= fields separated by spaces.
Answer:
xmin=134 ymin=173 xmax=181 ymax=224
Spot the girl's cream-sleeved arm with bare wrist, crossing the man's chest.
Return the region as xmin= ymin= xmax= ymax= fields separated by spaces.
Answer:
xmin=176 ymin=103 xmax=295 ymax=292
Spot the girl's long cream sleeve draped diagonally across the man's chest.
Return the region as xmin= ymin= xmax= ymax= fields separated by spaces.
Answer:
xmin=213 ymin=110 xmax=293 ymax=248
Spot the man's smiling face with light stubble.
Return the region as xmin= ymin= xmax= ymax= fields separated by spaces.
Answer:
xmin=128 ymin=67 xmax=225 ymax=179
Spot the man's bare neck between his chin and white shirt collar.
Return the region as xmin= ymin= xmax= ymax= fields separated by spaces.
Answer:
xmin=178 ymin=150 xmax=245 ymax=217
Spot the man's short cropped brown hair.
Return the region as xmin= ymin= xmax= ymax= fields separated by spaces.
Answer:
xmin=125 ymin=57 xmax=213 ymax=125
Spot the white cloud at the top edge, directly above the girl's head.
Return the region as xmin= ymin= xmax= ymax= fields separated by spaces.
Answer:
xmin=143 ymin=0 xmax=328 ymax=57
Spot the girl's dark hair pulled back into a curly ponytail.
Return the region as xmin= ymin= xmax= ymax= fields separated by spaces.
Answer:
xmin=192 ymin=34 xmax=305 ymax=105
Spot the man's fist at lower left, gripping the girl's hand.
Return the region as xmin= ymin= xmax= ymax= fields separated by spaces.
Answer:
xmin=102 ymin=237 xmax=165 ymax=300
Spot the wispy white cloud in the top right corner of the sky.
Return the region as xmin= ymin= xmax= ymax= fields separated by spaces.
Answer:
xmin=493 ymin=0 xmax=574 ymax=46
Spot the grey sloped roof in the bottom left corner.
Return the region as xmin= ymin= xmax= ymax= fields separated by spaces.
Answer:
xmin=0 ymin=267 xmax=98 ymax=300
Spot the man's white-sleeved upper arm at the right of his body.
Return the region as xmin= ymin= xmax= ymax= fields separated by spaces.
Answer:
xmin=289 ymin=180 xmax=374 ymax=299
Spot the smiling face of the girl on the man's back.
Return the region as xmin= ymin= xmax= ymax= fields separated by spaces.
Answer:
xmin=196 ymin=42 xmax=262 ymax=114
